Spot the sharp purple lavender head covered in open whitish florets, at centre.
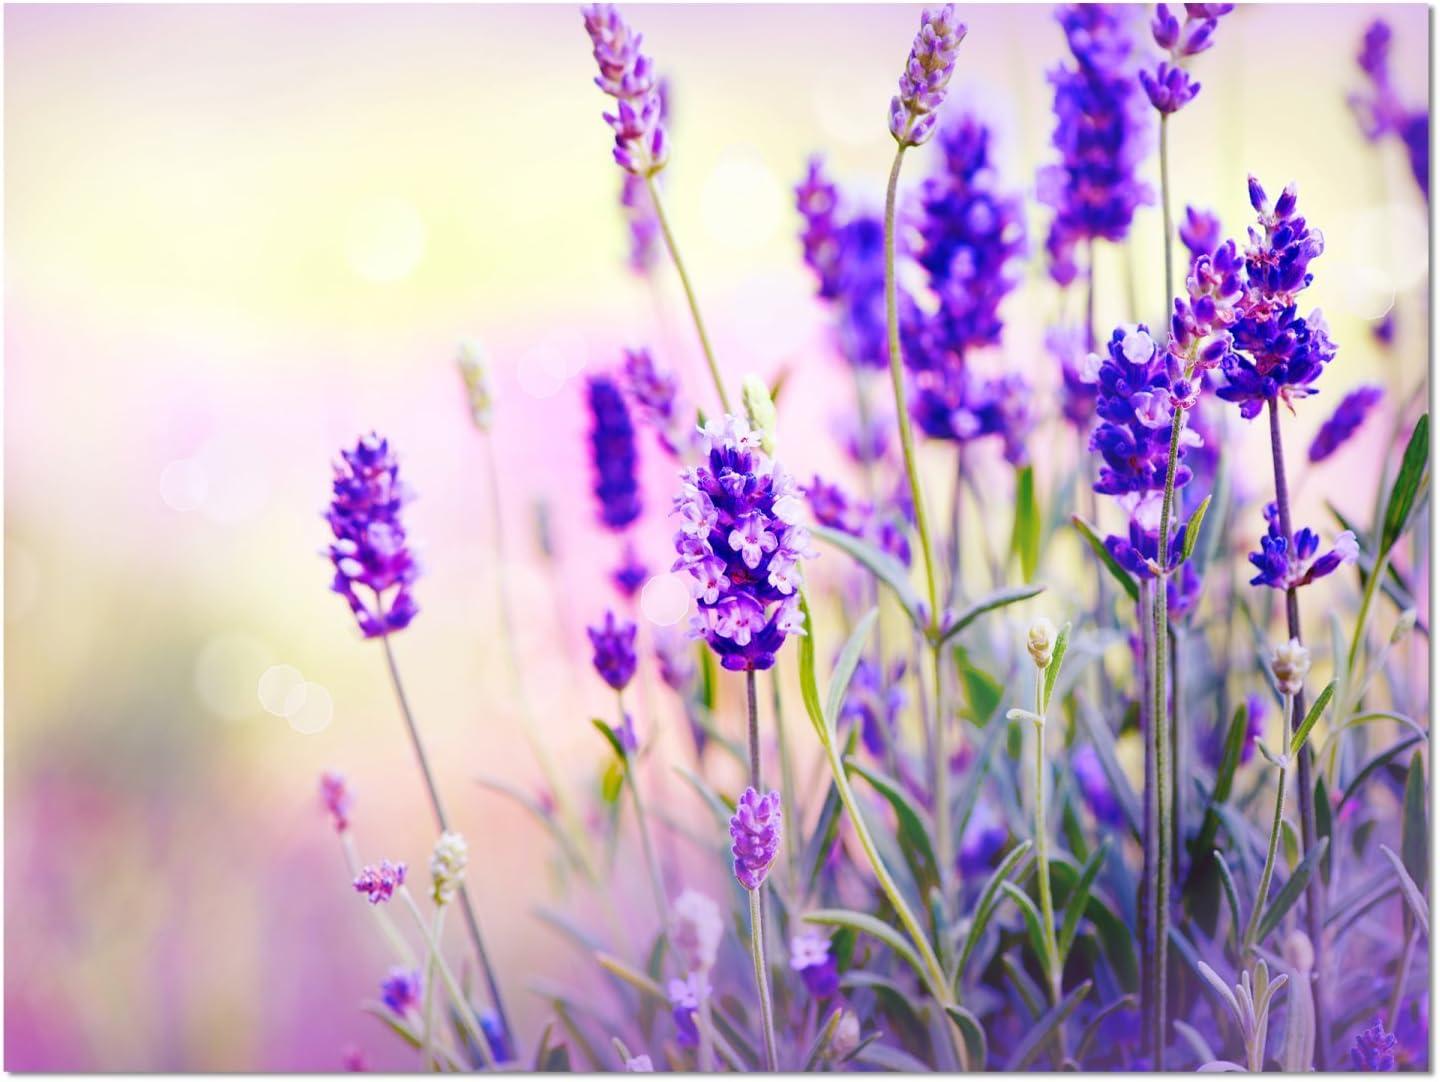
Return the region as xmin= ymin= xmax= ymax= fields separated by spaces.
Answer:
xmin=674 ymin=416 xmax=814 ymax=671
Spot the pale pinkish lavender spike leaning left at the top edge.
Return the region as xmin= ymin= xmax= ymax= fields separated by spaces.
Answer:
xmin=582 ymin=4 xmax=670 ymax=177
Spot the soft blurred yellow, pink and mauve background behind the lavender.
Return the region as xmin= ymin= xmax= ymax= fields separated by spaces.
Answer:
xmin=4 ymin=6 xmax=1430 ymax=1070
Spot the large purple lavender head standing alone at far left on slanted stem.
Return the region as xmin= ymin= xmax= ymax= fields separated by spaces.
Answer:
xmin=325 ymin=432 xmax=420 ymax=638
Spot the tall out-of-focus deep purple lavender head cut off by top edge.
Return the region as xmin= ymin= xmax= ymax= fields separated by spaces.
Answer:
xmin=1035 ymin=4 xmax=1151 ymax=285
